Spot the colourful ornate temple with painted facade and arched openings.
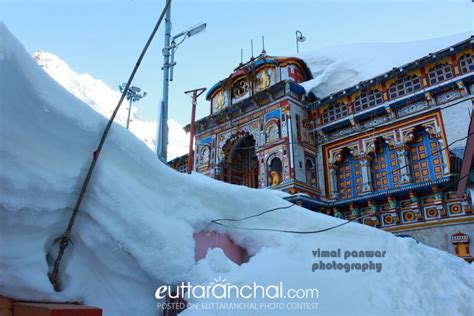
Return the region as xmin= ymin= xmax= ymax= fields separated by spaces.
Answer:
xmin=170 ymin=37 xmax=474 ymax=261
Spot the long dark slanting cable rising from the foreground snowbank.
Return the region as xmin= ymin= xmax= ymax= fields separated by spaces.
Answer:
xmin=49 ymin=0 xmax=171 ymax=292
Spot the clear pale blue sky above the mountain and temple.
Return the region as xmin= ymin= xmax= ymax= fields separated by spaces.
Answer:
xmin=0 ymin=0 xmax=473 ymax=124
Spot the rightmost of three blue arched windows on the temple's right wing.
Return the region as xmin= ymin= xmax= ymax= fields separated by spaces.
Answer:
xmin=409 ymin=130 xmax=443 ymax=182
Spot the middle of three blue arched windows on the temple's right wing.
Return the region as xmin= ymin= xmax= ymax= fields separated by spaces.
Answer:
xmin=372 ymin=140 xmax=400 ymax=191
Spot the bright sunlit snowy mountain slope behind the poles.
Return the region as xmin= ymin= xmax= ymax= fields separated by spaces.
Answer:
xmin=33 ymin=50 xmax=189 ymax=159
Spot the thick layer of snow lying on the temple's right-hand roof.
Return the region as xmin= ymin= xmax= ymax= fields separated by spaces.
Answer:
xmin=298 ymin=33 xmax=471 ymax=98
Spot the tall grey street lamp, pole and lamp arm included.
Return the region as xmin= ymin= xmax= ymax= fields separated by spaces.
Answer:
xmin=156 ymin=6 xmax=206 ymax=163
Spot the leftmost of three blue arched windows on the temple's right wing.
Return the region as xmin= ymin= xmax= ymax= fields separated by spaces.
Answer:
xmin=337 ymin=154 xmax=362 ymax=199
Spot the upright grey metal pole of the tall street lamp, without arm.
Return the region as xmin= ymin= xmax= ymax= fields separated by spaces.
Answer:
xmin=156 ymin=0 xmax=171 ymax=163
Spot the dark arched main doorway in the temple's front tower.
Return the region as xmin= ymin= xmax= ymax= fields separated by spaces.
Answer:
xmin=223 ymin=133 xmax=258 ymax=188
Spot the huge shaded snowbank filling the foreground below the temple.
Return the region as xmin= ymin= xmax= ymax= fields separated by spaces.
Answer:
xmin=0 ymin=23 xmax=474 ymax=316
